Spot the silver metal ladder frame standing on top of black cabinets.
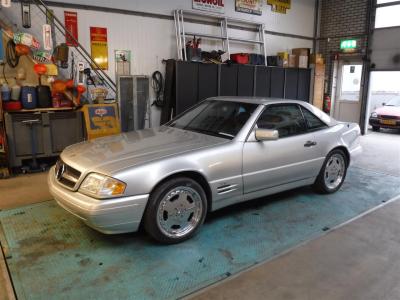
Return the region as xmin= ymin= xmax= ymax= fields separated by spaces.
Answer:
xmin=174 ymin=9 xmax=266 ymax=63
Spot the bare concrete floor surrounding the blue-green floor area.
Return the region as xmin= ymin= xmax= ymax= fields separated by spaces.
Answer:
xmin=0 ymin=131 xmax=400 ymax=300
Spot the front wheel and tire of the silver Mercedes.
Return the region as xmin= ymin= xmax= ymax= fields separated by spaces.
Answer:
xmin=144 ymin=177 xmax=207 ymax=244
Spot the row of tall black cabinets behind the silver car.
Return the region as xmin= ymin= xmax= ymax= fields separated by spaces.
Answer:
xmin=170 ymin=61 xmax=311 ymax=119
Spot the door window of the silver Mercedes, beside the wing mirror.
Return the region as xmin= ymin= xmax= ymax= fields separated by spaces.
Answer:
xmin=257 ymin=104 xmax=307 ymax=138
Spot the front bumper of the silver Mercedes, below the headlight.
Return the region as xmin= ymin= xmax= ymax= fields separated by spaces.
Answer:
xmin=47 ymin=167 xmax=149 ymax=234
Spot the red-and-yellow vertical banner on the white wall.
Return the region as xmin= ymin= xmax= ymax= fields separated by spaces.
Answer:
xmin=90 ymin=27 xmax=108 ymax=70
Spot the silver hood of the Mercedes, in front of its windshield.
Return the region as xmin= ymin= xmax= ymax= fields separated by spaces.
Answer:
xmin=61 ymin=126 xmax=230 ymax=174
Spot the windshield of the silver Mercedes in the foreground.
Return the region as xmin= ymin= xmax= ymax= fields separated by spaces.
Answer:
xmin=168 ymin=100 xmax=257 ymax=139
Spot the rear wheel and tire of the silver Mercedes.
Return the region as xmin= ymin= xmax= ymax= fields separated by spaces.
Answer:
xmin=313 ymin=149 xmax=349 ymax=194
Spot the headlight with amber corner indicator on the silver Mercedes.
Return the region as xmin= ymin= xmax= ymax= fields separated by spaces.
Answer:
xmin=79 ymin=173 xmax=126 ymax=198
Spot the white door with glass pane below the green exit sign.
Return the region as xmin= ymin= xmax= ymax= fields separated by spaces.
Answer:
xmin=333 ymin=61 xmax=363 ymax=123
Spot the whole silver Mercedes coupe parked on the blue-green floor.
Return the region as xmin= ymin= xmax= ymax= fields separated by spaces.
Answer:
xmin=48 ymin=97 xmax=361 ymax=243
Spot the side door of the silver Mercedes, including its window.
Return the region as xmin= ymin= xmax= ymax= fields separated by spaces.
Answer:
xmin=243 ymin=104 xmax=318 ymax=194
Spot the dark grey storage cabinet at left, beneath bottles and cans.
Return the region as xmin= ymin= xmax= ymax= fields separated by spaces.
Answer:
xmin=4 ymin=111 xmax=85 ymax=167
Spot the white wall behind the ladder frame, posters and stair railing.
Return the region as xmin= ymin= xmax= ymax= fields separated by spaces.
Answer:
xmin=4 ymin=0 xmax=315 ymax=124
